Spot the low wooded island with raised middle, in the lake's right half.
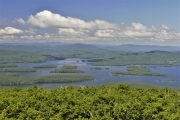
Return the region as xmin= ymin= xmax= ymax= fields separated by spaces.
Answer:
xmin=112 ymin=66 xmax=167 ymax=76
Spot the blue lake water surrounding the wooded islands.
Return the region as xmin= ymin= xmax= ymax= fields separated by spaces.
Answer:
xmin=0 ymin=58 xmax=180 ymax=88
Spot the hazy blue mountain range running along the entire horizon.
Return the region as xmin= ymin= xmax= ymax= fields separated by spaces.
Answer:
xmin=0 ymin=42 xmax=180 ymax=52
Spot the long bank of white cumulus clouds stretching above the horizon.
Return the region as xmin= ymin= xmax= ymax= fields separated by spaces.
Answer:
xmin=7 ymin=10 xmax=180 ymax=43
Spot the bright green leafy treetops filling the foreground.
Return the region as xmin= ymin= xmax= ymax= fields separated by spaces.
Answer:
xmin=0 ymin=84 xmax=180 ymax=120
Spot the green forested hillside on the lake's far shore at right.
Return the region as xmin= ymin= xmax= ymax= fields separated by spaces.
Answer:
xmin=93 ymin=51 xmax=180 ymax=66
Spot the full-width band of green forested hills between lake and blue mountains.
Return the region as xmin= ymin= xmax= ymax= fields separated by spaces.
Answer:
xmin=0 ymin=45 xmax=180 ymax=66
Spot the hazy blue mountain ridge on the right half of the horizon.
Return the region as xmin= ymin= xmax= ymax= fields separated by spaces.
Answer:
xmin=104 ymin=44 xmax=180 ymax=52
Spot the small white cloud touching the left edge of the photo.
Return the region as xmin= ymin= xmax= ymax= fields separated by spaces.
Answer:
xmin=0 ymin=27 xmax=23 ymax=35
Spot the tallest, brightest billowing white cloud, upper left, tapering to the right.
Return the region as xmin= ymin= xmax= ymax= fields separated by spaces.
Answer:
xmin=27 ymin=10 xmax=91 ymax=28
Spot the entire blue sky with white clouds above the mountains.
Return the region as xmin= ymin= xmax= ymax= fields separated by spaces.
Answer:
xmin=0 ymin=0 xmax=180 ymax=46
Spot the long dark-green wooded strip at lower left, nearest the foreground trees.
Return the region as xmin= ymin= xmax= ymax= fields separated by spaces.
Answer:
xmin=0 ymin=74 xmax=94 ymax=85
